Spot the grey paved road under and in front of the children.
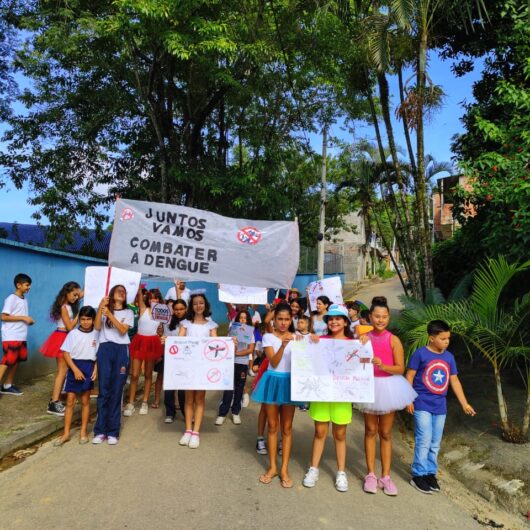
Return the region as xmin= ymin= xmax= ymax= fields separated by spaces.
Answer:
xmin=0 ymin=392 xmax=483 ymax=530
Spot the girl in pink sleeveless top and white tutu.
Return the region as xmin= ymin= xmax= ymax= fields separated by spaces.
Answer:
xmin=362 ymin=296 xmax=418 ymax=495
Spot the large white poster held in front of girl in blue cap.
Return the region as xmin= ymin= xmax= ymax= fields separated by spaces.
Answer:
xmin=291 ymin=339 xmax=374 ymax=403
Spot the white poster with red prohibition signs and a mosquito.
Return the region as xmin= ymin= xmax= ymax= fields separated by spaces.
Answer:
xmin=164 ymin=337 xmax=234 ymax=390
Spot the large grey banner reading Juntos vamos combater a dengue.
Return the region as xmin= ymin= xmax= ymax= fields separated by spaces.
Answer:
xmin=109 ymin=199 xmax=299 ymax=288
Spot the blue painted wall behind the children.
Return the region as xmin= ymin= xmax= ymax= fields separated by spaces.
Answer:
xmin=0 ymin=239 xmax=344 ymax=381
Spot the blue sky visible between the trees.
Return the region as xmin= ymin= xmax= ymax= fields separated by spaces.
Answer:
xmin=0 ymin=55 xmax=482 ymax=223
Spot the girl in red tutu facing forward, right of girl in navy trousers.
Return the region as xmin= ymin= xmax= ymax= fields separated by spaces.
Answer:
xmin=123 ymin=289 xmax=164 ymax=416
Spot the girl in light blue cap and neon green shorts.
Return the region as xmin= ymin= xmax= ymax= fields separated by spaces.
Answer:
xmin=303 ymin=304 xmax=352 ymax=491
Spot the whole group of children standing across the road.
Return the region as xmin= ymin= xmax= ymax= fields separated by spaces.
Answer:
xmin=0 ymin=274 xmax=475 ymax=496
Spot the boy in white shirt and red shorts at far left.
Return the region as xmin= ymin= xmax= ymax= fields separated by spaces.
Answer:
xmin=0 ymin=273 xmax=34 ymax=396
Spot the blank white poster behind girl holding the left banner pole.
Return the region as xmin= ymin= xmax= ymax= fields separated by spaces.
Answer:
xmin=83 ymin=267 xmax=142 ymax=309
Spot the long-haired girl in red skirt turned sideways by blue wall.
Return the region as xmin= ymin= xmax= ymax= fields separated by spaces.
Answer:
xmin=39 ymin=282 xmax=83 ymax=416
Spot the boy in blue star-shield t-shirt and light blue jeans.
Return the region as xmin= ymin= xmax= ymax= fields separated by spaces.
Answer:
xmin=406 ymin=320 xmax=476 ymax=493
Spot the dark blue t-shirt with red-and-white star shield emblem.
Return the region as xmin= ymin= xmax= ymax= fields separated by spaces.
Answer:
xmin=409 ymin=346 xmax=458 ymax=414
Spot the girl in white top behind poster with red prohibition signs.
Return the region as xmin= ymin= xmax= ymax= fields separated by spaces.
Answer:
xmin=179 ymin=294 xmax=218 ymax=449
